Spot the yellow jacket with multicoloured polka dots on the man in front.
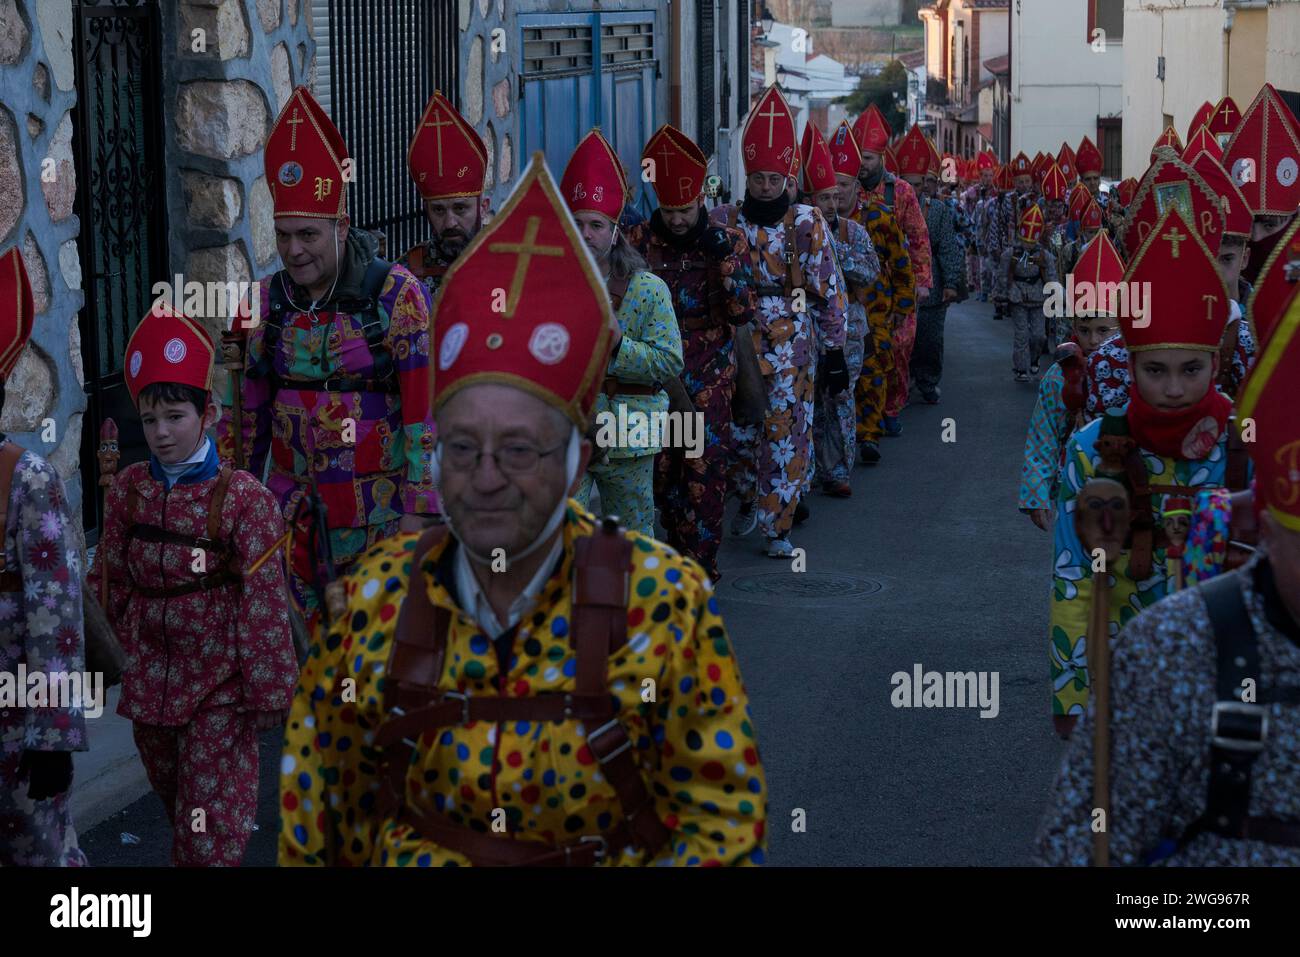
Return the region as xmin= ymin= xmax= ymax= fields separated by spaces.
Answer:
xmin=280 ymin=502 xmax=767 ymax=866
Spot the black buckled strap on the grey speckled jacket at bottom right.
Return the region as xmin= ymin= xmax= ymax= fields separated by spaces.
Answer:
xmin=1179 ymin=570 xmax=1300 ymax=848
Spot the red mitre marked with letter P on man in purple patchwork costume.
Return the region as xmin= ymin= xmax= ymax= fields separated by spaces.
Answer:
xmin=263 ymin=86 xmax=347 ymax=220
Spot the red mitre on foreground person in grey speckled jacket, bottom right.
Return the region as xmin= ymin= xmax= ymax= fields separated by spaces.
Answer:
xmin=1238 ymin=296 xmax=1300 ymax=532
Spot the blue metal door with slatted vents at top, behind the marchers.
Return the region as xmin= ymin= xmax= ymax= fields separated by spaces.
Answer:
xmin=519 ymin=10 xmax=658 ymax=216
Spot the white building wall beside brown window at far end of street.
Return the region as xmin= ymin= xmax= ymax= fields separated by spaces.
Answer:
xmin=1008 ymin=0 xmax=1123 ymax=160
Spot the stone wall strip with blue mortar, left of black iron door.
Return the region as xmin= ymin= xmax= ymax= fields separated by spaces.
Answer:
xmin=0 ymin=0 xmax=86 ymax=548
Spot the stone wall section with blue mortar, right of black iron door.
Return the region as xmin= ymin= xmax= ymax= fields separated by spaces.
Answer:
xmin=161 ymin=0 xmax=316 ymax=343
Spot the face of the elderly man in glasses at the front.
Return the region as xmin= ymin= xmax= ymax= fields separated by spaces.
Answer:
xmin=437 ymin=384 xmax=590 ymax=557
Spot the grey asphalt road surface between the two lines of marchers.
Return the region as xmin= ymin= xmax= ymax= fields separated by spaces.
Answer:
xmin=81 ymin=295 xmax=1061 ymax=866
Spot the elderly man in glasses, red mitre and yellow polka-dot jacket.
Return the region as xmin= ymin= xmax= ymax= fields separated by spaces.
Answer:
xmin=280 ymin=155 xmax=767 ymax=866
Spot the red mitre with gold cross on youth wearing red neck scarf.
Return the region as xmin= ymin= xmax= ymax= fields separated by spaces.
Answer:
xmin=1119 ymin=204 xmax=1230 ymax=352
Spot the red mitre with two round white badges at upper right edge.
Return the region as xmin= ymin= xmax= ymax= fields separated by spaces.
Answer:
xmin=1223 ymin=83 xmax=1300 ymax=216
